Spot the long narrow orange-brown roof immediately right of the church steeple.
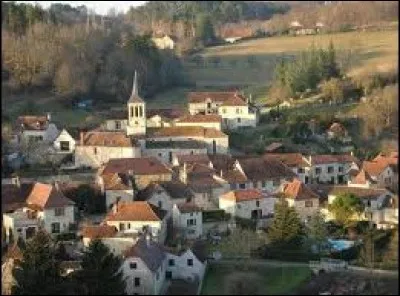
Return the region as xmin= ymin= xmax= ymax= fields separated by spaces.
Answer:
xmin=147 ymin=126 xmax=228 ymax=138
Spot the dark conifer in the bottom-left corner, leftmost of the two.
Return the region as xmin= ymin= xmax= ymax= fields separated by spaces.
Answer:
xmin=12 ymin=230 xmax=61 ymax=295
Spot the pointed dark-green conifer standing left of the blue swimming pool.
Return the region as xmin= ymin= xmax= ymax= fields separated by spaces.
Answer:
xmin=268 ymin=197 xmax=302 ymax=249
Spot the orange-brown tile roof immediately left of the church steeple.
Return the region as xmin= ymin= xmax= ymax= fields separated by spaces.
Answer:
xmin=79 ymin=131 xmax=138 ymax=147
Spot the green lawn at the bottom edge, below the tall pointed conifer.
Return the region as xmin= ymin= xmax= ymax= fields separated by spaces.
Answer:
xmin=201 ymin=264 xmax=311 ymax=295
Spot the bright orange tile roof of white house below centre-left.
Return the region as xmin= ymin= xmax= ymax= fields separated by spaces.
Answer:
xmin=105 ymin=201 xmax=166 ymax=221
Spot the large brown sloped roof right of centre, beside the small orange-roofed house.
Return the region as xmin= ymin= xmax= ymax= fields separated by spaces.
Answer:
xmin=238 ymin=157 xmax=296 ymax=181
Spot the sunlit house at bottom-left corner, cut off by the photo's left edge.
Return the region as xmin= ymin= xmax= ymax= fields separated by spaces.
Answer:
xmin=1 ymin=242 xmax=23 ymax=295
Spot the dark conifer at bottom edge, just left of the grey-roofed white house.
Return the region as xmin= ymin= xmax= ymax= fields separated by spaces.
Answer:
xmin=75 ymin=240 xmax=125 ymax=295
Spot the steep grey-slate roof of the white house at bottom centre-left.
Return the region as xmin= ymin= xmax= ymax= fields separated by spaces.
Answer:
xmin=124 ymin=238 xmax=166 ymax=272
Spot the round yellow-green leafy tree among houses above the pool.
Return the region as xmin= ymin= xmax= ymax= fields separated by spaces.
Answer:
xmin=328 ymin=193 xmax=364 ymax=227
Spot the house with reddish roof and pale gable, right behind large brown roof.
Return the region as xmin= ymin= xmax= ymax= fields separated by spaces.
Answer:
xmin=264 ymin=153 xmax=311 ymax=184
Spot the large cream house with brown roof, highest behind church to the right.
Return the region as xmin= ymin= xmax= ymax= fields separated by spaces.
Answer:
xmin=188 ymin=92 xmax=258 ymax=129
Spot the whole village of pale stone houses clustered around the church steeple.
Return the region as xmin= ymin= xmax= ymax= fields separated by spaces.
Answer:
xmin=2 ymin=72 xmax=398 ymax=295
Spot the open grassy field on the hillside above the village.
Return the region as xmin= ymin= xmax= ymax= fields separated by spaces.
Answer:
xmin=185 ymin=30 xmax=398 ymax=101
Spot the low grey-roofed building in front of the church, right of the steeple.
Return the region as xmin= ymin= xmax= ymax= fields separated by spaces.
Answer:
xmin=143 ymin=140 xmax=207 ymax=164
